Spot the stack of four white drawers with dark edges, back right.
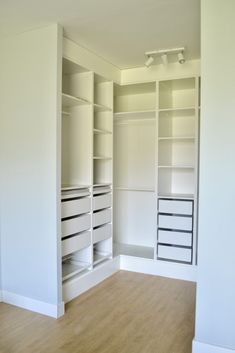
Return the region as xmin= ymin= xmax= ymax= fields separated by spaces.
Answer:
xmin=157 ymin=198 xmax=193 ymax=264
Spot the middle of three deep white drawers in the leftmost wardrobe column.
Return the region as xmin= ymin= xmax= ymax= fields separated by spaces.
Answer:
xmin=61 ymin=214 xmax=91 ymax=237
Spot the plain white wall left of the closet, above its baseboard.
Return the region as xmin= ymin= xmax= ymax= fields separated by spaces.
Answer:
xmin=0 ymin=25 xmax=62 ymax=305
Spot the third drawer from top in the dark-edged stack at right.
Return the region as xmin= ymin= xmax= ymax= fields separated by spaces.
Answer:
xmin=158 ymin=230 xmax=192 ymax=246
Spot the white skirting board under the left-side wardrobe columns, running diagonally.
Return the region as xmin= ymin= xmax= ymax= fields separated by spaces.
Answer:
xmin=63 ymin=256 xmax=120 ymax=303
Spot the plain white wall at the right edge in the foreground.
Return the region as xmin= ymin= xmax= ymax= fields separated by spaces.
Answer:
xmin=194 ymin=0 xmax=235 ymax=353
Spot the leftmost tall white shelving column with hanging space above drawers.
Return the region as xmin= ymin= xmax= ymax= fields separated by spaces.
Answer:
xmin=61 ymin=58 xmax=93 ymax=300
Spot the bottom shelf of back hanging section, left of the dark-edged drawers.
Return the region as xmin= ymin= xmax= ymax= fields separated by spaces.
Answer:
xmin=114 ymin=243 xmax=154 ymax=259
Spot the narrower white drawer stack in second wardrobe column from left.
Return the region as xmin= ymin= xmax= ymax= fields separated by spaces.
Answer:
xmin=93 ymin=187 xmax=112 ymax=262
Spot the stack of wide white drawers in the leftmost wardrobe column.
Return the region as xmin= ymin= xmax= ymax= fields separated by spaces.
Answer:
xmin=61 ymin=189 xmax=91 ymax=277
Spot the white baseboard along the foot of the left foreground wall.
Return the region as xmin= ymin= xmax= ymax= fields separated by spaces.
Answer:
xmin=2 ymin=291 xmax=64 ymax=318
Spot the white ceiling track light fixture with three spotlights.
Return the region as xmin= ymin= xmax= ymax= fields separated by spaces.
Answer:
xmin=145 ymin=47 xmax=185 ymax=67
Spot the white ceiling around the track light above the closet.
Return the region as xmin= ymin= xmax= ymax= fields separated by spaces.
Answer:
xmin=0 ymin=0 xmax=200 ymax=69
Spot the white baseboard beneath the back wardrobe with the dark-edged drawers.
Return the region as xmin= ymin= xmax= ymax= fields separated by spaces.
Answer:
xmin=120 ymin=255 xmax=197 ymax=282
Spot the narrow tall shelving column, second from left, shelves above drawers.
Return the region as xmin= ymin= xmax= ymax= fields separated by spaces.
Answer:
xmin=92 ymin=74 xmax=113 ymax=268
